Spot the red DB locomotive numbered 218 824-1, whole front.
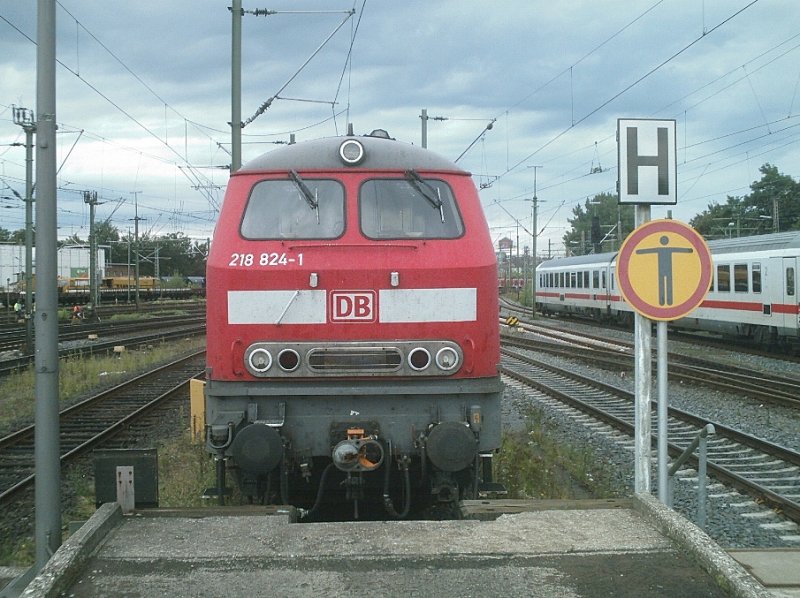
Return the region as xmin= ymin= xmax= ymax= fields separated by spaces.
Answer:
xmin=206 ymin=135 xmax=502 ymax=516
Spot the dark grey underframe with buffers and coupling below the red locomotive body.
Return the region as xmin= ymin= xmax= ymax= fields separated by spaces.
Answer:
xmin=206 ymin=377 xmax=502 ymax=516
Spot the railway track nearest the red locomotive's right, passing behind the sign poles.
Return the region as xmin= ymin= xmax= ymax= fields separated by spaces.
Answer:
xmin=501 ymin=348 xmax=800 ymax=523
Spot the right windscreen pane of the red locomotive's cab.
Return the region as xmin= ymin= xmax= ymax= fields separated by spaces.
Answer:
xmin=358 ymin=177 xmax=464 ymax=239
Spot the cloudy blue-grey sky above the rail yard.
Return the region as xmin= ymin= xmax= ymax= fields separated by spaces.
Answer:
xmin=0 ymin=0 xmax=800 ymax=255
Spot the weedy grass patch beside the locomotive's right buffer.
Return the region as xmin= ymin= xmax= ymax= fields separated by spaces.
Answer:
xmin=495 ymin=408 xmax=618 ymax=499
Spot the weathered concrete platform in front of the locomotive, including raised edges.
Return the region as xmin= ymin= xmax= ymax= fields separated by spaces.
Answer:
xmin=12 ymin=496 xmax=771 ymax=598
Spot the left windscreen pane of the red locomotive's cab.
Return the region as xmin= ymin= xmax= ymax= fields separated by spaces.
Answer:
xmin=240 ymin=177 xmax=344 ymax=239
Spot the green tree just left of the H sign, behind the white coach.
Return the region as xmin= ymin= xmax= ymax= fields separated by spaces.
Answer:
xmin=563 ymin=193 xmax=634 ymax=255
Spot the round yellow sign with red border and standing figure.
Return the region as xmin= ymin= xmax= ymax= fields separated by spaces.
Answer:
xmin=616 ymin=220 xmax=711 ymax=320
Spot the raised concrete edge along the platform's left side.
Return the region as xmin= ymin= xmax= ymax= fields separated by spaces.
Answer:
xmin=21 ymin=503 xmax=122 ymax=598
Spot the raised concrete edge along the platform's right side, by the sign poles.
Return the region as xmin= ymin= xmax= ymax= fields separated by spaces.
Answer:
xmin=633 ymin=494 xmax=774 ymax=598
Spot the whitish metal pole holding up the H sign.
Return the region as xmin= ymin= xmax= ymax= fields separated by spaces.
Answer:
xmin=634 ymin=204 xmax=653 ymax=494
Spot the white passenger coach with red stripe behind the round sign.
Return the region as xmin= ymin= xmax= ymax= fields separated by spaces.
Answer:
xmin=536 ymin=231 xmax=800 ymax=344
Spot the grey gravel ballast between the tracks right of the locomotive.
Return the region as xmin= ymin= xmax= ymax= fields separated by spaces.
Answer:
xmin=506 ymin=320 xmax=800 ymax=548
